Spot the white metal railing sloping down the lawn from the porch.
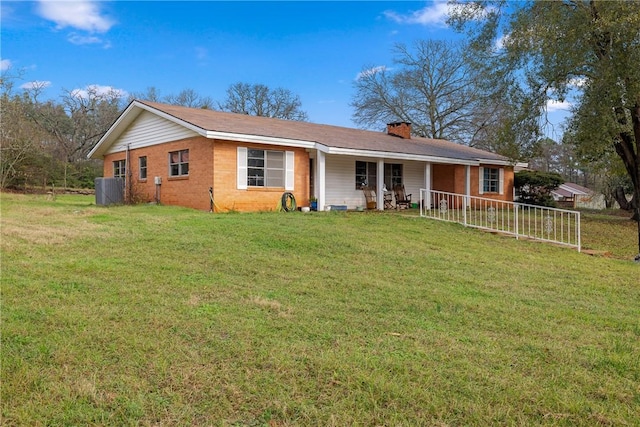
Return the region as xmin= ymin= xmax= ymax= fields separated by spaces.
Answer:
xmin=420 ymin=189 xmax=581 ymax=251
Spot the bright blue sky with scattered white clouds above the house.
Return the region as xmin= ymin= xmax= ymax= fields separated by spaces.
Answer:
xmin=0 ymin=0 xmax=559 ymax=137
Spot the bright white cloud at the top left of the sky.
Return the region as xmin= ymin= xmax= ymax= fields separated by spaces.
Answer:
xmin=38 ymin=0 xmax=115 ymax=33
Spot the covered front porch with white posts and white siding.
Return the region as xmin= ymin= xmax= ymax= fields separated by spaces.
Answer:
xmin=309 ymin=150 xmax=513 ymax=211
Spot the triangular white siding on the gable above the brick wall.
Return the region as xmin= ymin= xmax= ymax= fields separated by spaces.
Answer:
xmin=107 ymin=111 xmax=198 ymax=154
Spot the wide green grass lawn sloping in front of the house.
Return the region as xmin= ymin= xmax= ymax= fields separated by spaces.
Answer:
xmin=0 ymin=194 xmax=640 ymax=426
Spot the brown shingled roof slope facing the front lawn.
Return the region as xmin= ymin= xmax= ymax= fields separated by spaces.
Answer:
xmin=99 ymin=101 xmax=508 ymax=163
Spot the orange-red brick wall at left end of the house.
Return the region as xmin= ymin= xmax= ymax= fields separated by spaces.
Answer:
xmin=104 ymin=137 xmax=309 ymax=212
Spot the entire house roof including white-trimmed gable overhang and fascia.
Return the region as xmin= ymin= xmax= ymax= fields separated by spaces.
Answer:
xmin=90 ymin=100 xmax=509 ymax=164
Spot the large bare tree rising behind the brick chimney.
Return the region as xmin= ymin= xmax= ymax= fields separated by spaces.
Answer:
xmin=351 ymin=40 xmax=508 ymax=145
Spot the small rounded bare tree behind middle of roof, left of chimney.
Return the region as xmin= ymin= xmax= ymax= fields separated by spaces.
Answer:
xmin=218 ymin=83 xmax=308 ymax=121
